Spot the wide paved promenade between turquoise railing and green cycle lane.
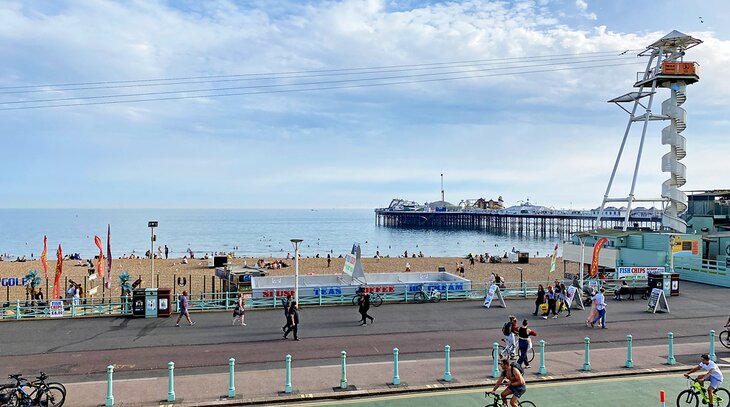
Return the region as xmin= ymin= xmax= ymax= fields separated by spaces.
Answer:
xmin=0 ymin=282 xmax=730 ymax=406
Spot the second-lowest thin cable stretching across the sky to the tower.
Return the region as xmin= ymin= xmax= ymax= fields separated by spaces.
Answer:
xmin=0 ymin=57 xmax=635 ymax=105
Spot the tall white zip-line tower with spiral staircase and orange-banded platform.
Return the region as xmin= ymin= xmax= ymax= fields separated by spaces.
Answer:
xmin=597 ymin=30 xmax=702 ymax=233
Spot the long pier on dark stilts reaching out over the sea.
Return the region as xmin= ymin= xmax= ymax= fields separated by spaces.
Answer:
xmin=375 ymin=208 xmax=662 ymax=236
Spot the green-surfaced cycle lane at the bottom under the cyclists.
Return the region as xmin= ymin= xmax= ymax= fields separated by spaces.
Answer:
xmin=278 ymin=374 xmax=689 ymax=407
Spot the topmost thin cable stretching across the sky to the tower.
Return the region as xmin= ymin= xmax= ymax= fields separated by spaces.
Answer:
xmin=0 ymin=49 xmax=640 ymax=90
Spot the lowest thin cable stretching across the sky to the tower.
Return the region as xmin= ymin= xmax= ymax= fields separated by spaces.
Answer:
xmin=0 ymin=61 xmax=643 ymax=111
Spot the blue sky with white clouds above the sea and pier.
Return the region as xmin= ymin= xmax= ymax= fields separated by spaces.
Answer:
xmin=0 ymin=0 xmax=730 ymax=208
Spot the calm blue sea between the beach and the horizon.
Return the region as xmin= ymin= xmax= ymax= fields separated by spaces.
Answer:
xmin=0 ymin=209 xmax=556 ymax=259
